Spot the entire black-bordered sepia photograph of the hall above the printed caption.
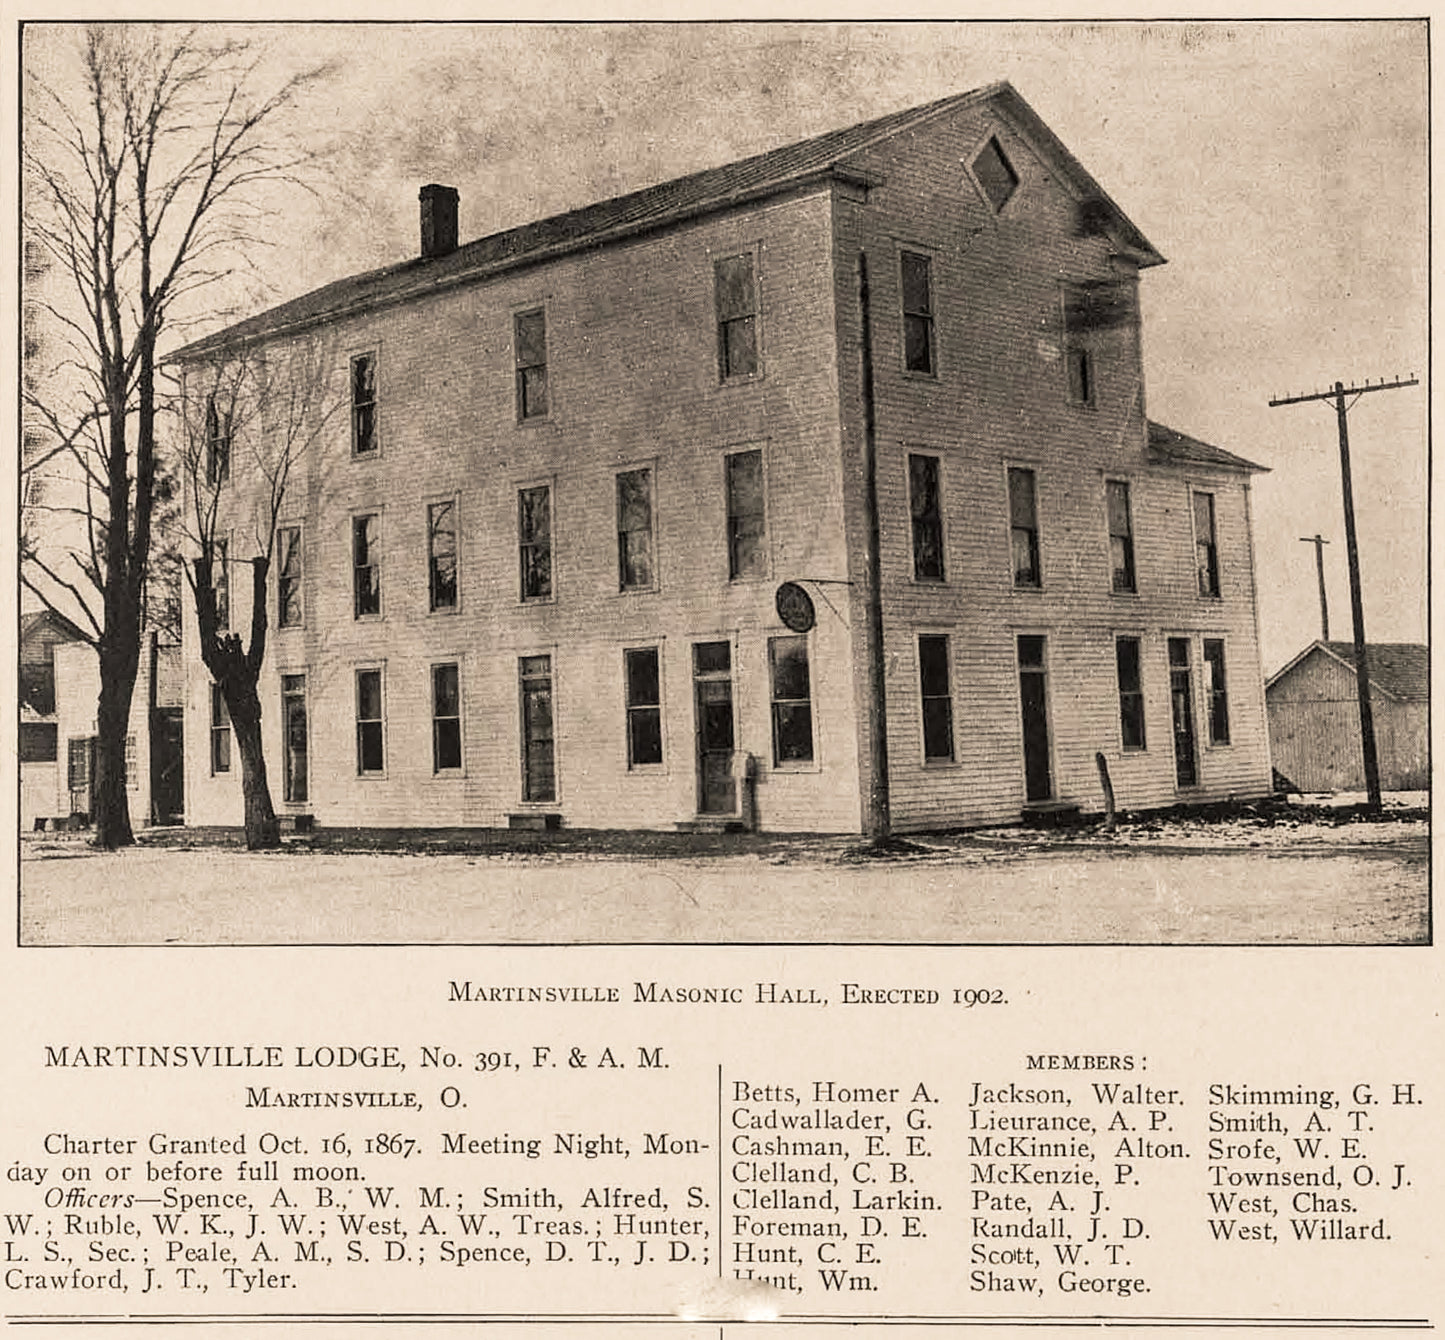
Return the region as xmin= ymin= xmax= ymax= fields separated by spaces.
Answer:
xmin=16 ymin=20 xmax=1432 ymax=947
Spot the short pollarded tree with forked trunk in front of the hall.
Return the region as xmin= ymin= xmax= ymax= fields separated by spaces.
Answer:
xmin=181 ymin=337 xmax=344 ymax=850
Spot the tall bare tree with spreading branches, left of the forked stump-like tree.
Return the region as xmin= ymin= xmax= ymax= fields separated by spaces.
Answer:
xmin=20 ymin=25 xmax=324 ymax=847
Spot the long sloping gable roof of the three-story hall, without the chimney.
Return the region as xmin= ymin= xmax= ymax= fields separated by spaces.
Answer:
xmin=171 ymin=82 xmax=1163 ymax=361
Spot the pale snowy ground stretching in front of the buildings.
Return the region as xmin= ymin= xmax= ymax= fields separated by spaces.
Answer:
xmin=20 ymin=798 xmax=1431 ymax=945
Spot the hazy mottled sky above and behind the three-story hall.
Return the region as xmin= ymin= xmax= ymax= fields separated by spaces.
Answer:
xmin=16 ymin=20 xmax=1429 ymax=674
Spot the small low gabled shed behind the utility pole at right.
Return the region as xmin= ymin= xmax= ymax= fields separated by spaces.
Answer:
xmin=1264 ymin=642 xmax=1431 ymax=791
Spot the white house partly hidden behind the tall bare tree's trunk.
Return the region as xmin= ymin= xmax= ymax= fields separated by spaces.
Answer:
xmin=20 ymin=611 xmax=184 ymax=831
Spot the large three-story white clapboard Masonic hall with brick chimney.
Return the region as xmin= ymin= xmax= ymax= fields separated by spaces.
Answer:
xmin=176 ymin=84 xmax=1270 ymax=831
